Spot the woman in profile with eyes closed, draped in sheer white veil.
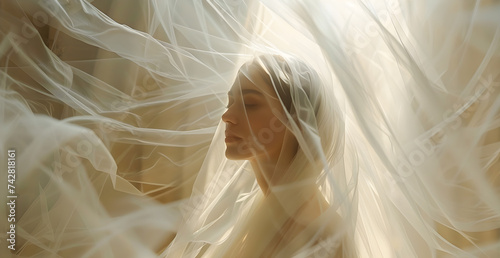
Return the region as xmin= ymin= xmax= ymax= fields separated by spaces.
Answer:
xmin=167 ymin=55 xmax=353 ymax=257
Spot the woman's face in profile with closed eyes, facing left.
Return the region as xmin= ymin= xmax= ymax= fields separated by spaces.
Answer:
xmin=222 ymin=69 xmax=287 ymax=160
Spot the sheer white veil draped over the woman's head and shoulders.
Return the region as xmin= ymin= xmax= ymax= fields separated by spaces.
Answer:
xmin=167 ymin=54 xmax=356 ymax=257
